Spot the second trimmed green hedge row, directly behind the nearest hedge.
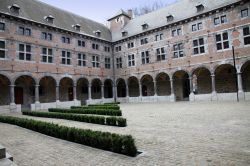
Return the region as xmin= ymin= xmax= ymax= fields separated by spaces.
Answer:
xmin=22 ymin=111 xmax=127 ymax=127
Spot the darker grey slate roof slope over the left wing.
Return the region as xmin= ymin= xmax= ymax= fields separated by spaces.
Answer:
xmin=0 ymin=0 xmax=111 ymax=41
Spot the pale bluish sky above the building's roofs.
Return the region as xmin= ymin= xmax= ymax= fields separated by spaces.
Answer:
xmin=40 ymin=0 xmax=176 ymax=23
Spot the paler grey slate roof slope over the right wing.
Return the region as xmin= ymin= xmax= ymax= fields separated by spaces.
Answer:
xmin=112 ymin=0 xmax=240 ymax=41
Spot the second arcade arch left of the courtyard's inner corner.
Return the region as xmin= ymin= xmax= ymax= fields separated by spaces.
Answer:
xmin=91 ymin=78 xmax=102 ymax=99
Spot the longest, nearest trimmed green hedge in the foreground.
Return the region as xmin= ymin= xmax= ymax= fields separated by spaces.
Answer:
xmin=0 ymin=116 xmax=137 ymax=156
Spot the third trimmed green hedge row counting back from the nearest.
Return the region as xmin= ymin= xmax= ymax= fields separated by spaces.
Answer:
xmin=48 ymin=107 xmax=122 ymax=116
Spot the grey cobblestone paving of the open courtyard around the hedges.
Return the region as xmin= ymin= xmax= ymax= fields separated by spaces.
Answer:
xmin=0 ymin=102 xmax=250 ymax=166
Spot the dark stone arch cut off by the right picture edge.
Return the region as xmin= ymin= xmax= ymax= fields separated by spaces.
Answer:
xmin=240 ymin=60 xmax=250 ymax=92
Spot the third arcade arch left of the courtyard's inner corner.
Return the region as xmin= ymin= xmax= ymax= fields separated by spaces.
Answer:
xmin=76 ymin=77 xmax=89 ymax=105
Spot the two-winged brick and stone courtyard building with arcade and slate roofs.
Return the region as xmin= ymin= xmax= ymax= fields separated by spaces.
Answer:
xmin=0 ymin=0 xmax=250 ymax=111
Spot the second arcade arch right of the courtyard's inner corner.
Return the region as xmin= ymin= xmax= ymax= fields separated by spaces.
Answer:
xmin=128 ymin=76 xmax=140 ymax=97
